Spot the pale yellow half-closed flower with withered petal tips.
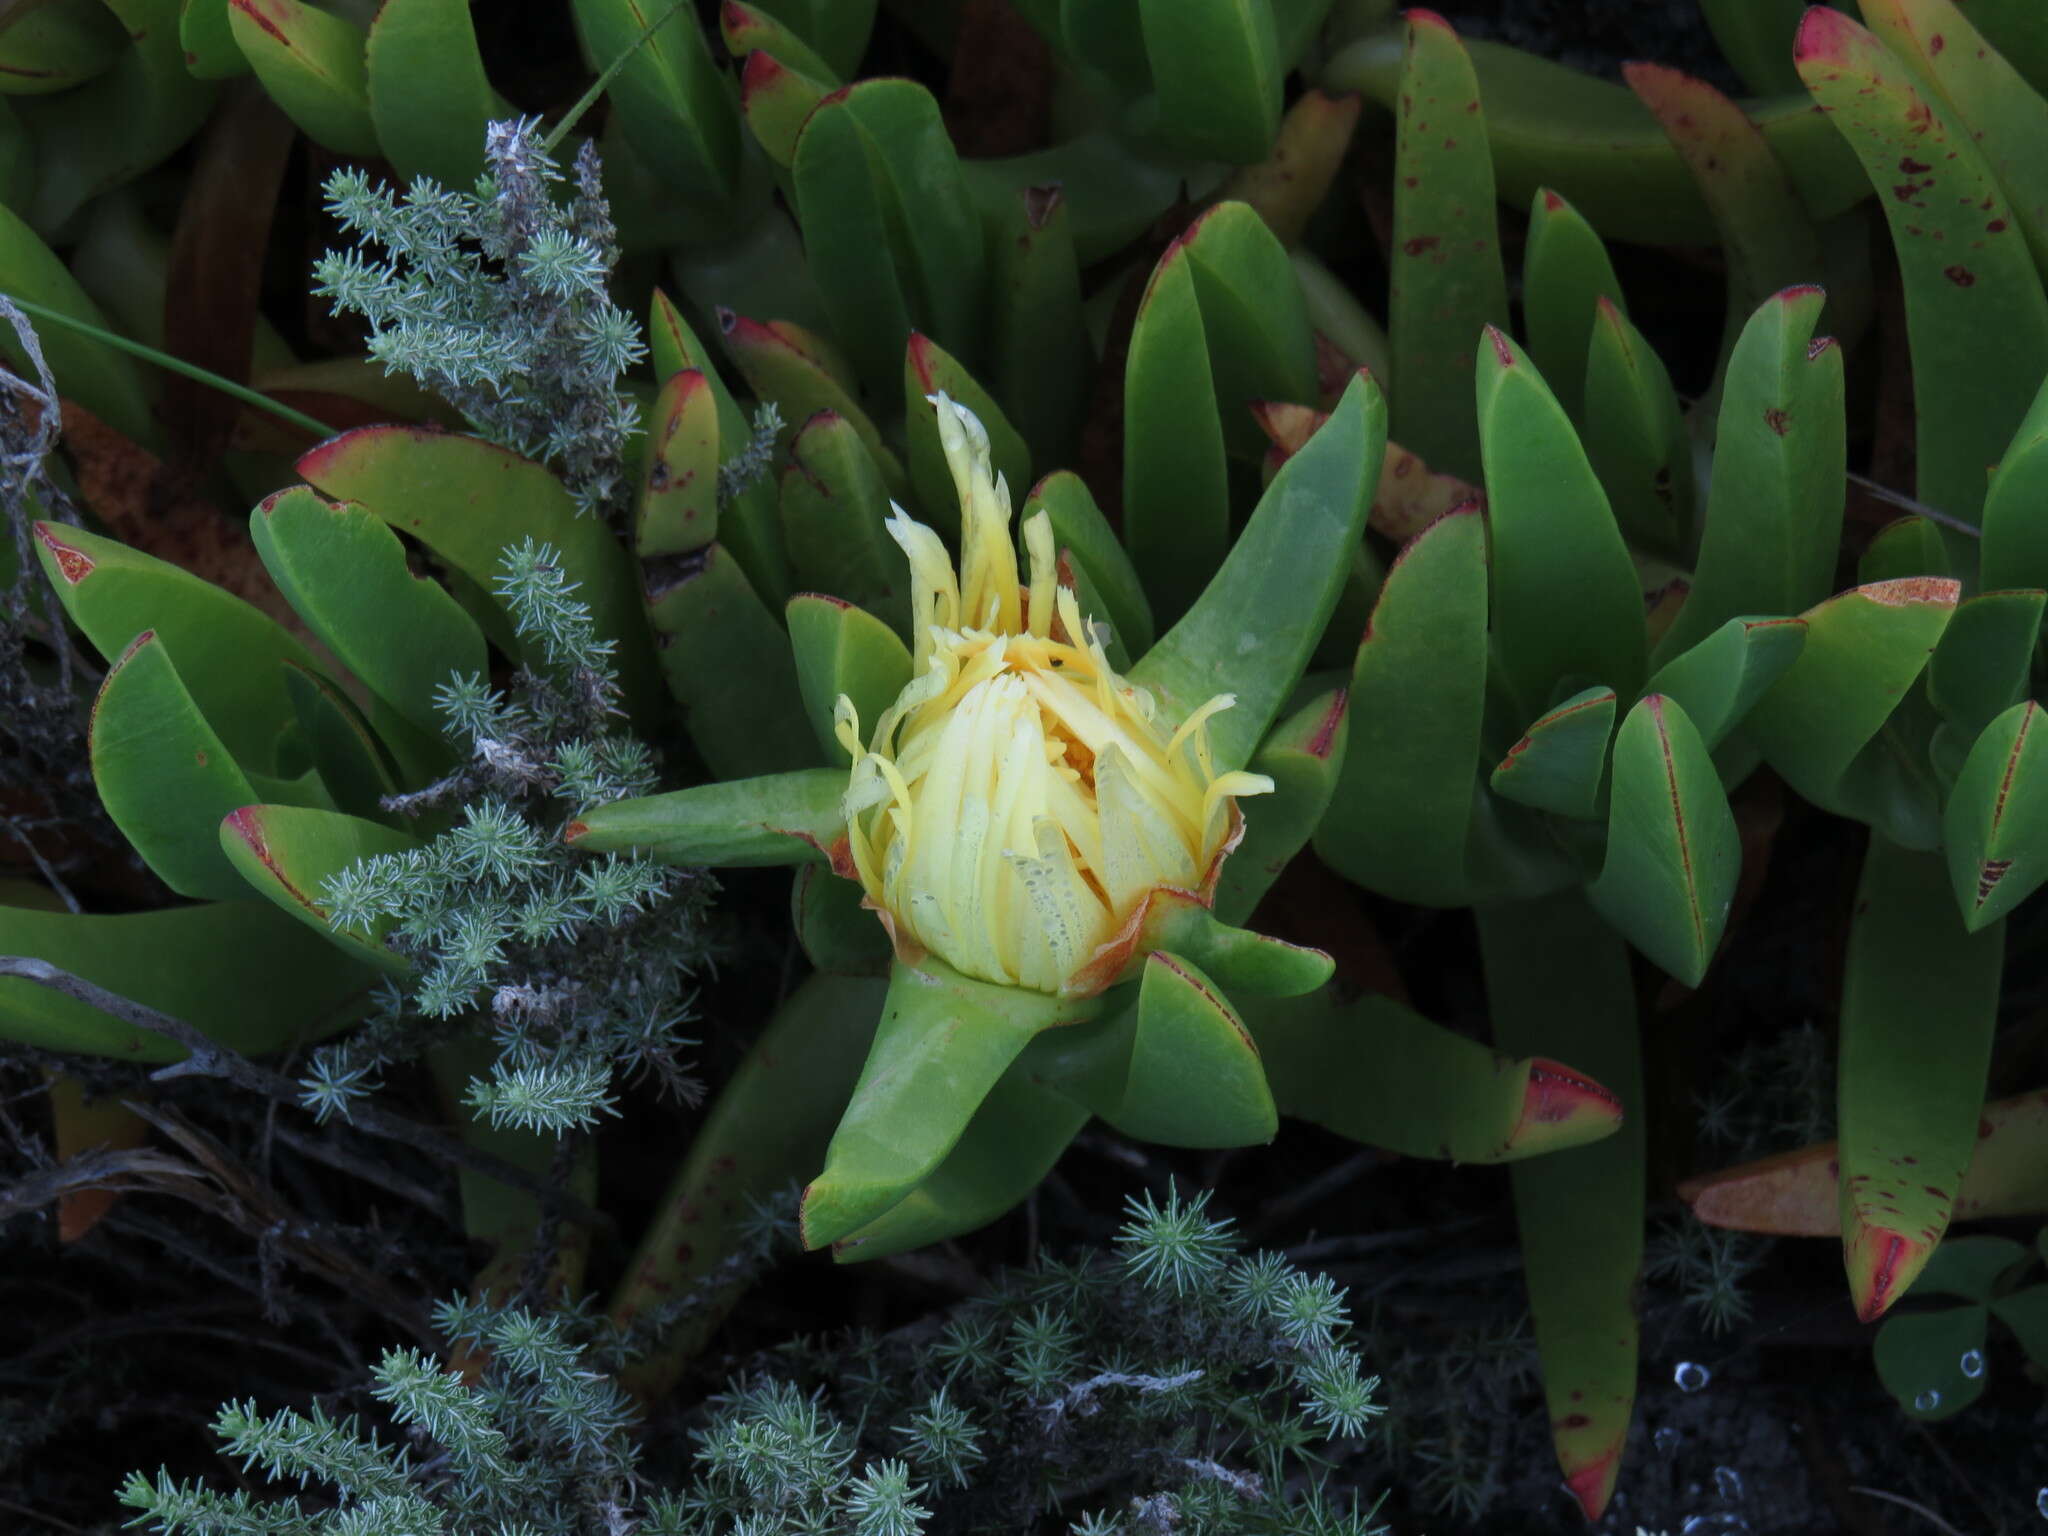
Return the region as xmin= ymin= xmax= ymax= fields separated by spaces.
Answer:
xmin=836 ymin=395 xmax=1272 ymax=995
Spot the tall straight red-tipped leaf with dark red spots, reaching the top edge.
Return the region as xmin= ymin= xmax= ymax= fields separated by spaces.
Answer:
xmin=1386 ymin=10 xmax=1515 ymax=481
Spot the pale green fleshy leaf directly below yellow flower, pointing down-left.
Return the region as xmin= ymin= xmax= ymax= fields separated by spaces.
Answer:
xmin=801 ymin=958 xmax=1096 ymax=1247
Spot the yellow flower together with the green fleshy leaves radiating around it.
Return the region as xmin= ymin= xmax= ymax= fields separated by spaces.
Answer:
xmin=567 ymin=377 xmax=1384 ymax=1262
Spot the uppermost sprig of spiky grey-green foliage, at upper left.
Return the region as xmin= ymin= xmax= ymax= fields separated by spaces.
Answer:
xmin=313 ymin=119 xmax=645 ymax=514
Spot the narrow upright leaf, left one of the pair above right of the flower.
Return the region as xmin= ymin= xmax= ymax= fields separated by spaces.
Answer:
xmin=1122 ymin=242 xmax=1231 ymax=618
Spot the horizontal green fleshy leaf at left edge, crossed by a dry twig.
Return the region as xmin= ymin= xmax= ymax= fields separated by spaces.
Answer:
xmin=0 ymin=901 xmax=377 ymax=1061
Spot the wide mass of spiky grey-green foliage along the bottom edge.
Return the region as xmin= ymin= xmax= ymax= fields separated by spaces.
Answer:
xmin=121 ymin=1194 xmax=1378 ymax=1536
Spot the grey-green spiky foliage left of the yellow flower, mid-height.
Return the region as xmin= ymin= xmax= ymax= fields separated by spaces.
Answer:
xmin=305 ymin=541 xmax=711 ymax=1133
